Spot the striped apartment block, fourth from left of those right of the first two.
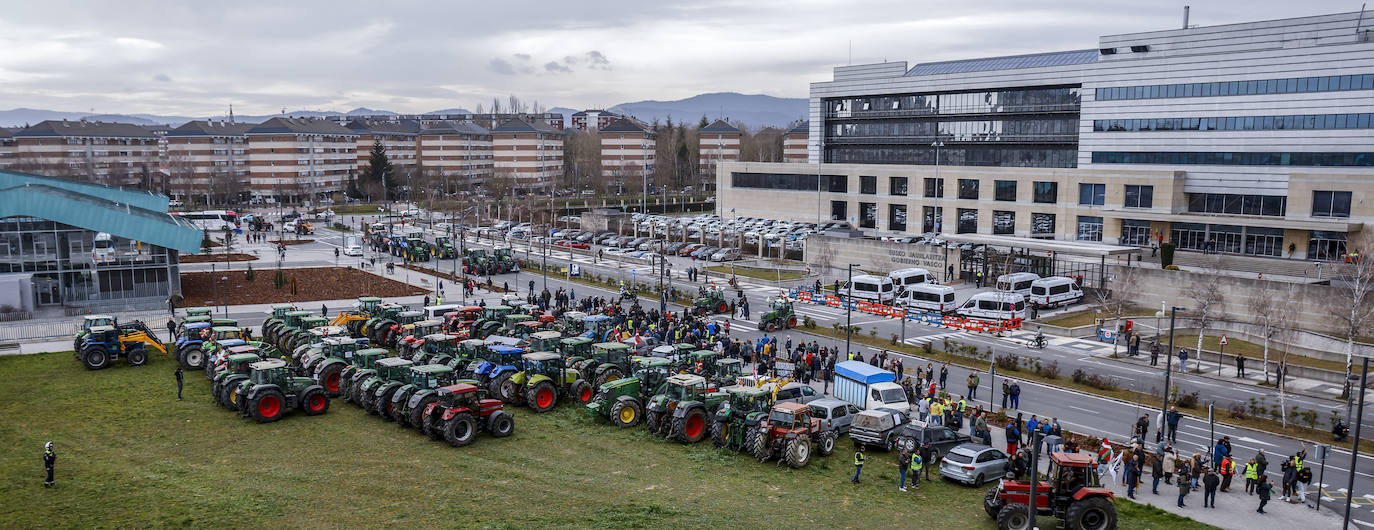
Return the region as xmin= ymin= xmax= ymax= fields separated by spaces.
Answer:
xmin=492 ymin=119 xmax=563 ymax=192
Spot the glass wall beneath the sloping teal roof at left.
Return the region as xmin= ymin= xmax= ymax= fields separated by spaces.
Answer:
xmin=0 ymin=217 xmax=180 ymax=306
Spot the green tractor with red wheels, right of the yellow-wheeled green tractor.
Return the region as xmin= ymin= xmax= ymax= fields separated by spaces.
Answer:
xmin=644 ymin=373 xmax=730 ymax=443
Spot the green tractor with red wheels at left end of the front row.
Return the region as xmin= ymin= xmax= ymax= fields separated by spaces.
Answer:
xmin=236 ymin=358 xmax=330 ymax=423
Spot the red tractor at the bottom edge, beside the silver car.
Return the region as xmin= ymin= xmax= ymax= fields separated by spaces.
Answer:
xmin=982 ymin=453 xmax=1117 ymax=530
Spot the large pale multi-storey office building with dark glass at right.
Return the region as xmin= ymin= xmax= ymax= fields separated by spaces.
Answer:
xmin=719 ymin=12 xmax=1374 ymax=260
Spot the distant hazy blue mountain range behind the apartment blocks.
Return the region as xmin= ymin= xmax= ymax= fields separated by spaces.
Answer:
xmin=0 ymin=92 xmax=807 ymax=128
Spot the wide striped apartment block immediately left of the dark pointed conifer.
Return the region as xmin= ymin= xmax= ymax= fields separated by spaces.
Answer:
xmin=245 ymin=118 xmax=359 ymax=202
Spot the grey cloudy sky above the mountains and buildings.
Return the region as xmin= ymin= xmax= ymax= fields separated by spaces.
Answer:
xmin=0 ymin=0 xmax=1359 ymax=115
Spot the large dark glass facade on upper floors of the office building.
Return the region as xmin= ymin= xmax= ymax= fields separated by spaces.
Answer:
xmin=823 ymin=87 xmax=1081 ymax=168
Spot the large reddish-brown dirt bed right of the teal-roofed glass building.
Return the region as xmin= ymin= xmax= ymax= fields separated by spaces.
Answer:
xmin=181 ymin=266 xmax=429 ymax=308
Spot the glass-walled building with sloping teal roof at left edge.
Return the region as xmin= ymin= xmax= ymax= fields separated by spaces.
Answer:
xmin=0 ymin=170 xmax=202 ymax=314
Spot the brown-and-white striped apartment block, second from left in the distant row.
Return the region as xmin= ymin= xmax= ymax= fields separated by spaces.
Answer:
xmin=164 ymin=121 xmax=256 ymax=205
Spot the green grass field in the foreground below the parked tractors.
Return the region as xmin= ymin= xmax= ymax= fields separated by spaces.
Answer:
xmin=0 ymin=353 xmax=1202 ymax=529
